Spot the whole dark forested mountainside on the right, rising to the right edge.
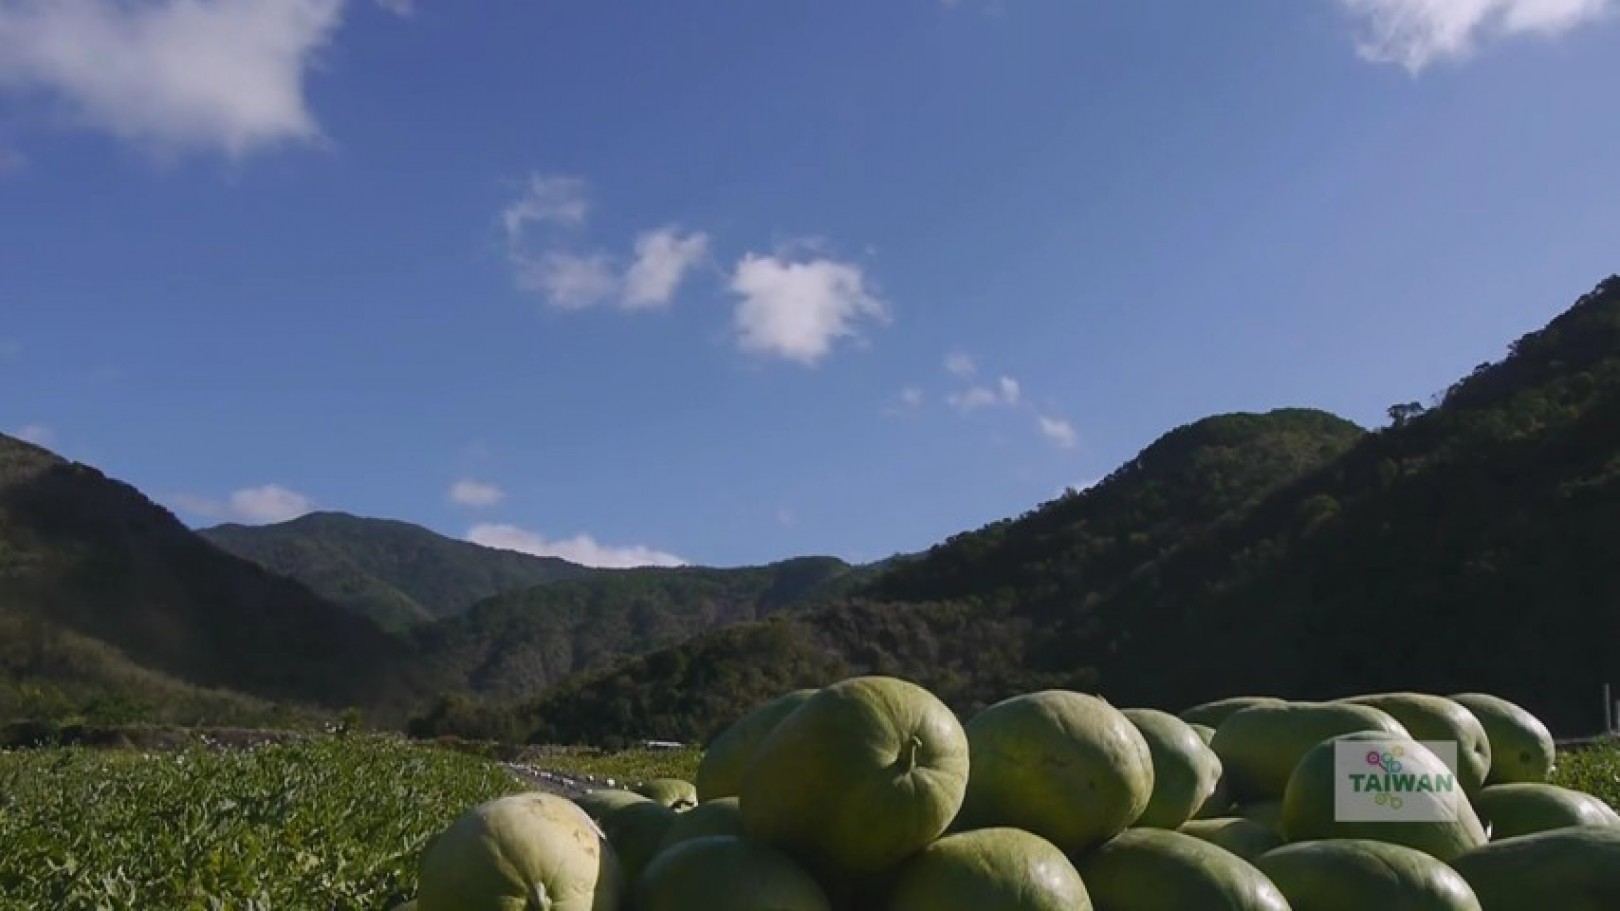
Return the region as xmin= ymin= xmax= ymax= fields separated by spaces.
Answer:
xmin=479 ymin=277 xmax=1620 ymax=742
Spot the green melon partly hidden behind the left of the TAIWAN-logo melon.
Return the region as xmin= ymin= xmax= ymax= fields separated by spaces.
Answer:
xmin=1210 ymin=702 xmax=1408 ymax=802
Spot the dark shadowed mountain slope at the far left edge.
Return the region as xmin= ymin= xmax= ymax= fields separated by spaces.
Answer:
xmin=0 ymin=436 xmax=436 ymax=720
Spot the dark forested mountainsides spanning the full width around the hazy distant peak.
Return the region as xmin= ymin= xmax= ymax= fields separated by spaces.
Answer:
xmin=0 ymin=272 xmax=1620 ymax=742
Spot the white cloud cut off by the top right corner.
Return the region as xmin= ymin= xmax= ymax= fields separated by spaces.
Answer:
xmin=1338 ymin=0 xmax=1614 ymax=73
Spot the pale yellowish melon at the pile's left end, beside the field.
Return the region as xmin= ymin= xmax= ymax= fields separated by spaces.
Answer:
xmin=416 ymin=793 xmax=625 ymax=911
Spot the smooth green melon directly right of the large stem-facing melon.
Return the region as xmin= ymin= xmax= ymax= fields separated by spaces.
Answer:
xmin=956 ymin=689 xmax=1153 ymax=858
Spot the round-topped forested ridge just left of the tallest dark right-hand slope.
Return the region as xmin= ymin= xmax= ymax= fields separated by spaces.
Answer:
xmin=484 ymin=408 xmax=1364 ymax=742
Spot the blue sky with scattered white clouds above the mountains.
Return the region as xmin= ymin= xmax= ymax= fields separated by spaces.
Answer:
xmin=0 ymin=0 xmax=1620 ymax=564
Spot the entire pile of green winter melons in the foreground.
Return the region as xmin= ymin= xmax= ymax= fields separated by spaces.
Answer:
xmin=392 ymin=676 xmax=1620 ymax=911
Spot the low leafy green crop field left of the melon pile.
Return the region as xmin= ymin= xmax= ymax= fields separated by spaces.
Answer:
xmin=0 ymin=738 xmax=522 ymax=911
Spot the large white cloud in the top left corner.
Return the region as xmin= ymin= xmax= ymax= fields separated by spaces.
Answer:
xmin=0 ymin=0 xmax=343 ymax=157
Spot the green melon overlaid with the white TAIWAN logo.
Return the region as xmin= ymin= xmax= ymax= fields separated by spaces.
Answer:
xmin=1283 ymin=731 xmax=1486 ymax=861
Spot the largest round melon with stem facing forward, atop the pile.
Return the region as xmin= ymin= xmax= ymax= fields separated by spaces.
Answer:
xmin=739 ymin=676 xmax=969 ymax=872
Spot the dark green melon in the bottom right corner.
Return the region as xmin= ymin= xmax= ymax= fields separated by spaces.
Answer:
xmin=1452 ymin=825 xmax=1620 ymax=911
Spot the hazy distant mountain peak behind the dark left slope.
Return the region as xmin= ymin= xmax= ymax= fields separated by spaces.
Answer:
xmin=199 ymin=512 xmax=591 ymax=631
